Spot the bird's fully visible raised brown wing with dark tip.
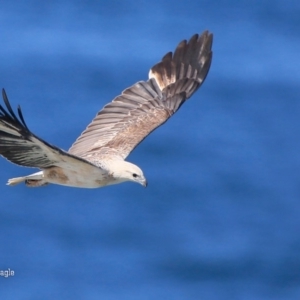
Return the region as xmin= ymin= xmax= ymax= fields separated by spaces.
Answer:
xmin=69 ymin=31 xmax=212 ymax=161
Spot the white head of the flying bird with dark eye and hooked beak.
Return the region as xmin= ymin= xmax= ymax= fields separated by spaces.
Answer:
xmin=112 ymin=160 xmax=147 ymax=187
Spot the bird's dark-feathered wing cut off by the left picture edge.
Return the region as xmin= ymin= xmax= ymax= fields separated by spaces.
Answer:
xmin=0 ymin=89 xmax=97 ymax=169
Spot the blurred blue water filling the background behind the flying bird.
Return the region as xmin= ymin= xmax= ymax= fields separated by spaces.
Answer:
xmin=0 ymin=0 xmax=300 ymax=300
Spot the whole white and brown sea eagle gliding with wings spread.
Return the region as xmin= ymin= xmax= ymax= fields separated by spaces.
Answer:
xmin=0 ymin=31 xmax=213 ymax=188
